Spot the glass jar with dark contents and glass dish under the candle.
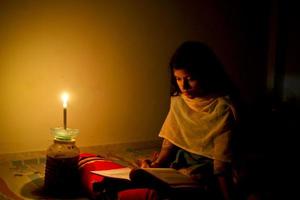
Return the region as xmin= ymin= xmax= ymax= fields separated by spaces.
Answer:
xmin=44 ymin=127 xmax=80 ymax=195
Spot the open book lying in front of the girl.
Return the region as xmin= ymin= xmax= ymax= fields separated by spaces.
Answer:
xmin=92 ymin=167 xmax=201 ymax=188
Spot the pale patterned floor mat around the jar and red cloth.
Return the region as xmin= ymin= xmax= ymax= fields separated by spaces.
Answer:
xmin=0 ymin=141 xmax=160 ymax=200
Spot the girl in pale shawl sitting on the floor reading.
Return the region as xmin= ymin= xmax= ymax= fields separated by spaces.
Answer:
xmin=141 ymin=41 xmax=237 ymax=199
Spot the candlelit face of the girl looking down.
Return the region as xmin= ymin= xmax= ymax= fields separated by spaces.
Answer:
xmin=173 ymin=69 xmax=202 ymax=99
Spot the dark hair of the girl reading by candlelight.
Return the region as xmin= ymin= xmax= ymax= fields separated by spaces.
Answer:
xmin=169 ymin=41 xmax=235 ymax=96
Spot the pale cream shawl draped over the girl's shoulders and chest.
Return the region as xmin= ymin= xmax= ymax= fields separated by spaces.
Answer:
xmin=159 ymin=95 xmax=235 ymax=162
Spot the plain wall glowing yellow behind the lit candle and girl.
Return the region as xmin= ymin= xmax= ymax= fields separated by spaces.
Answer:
xmin=0 ymin=0 xmax=268 ymax=153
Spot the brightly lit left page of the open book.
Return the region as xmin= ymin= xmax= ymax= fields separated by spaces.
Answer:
xmin=91 ymin=167 xmax=131 ymax=180
